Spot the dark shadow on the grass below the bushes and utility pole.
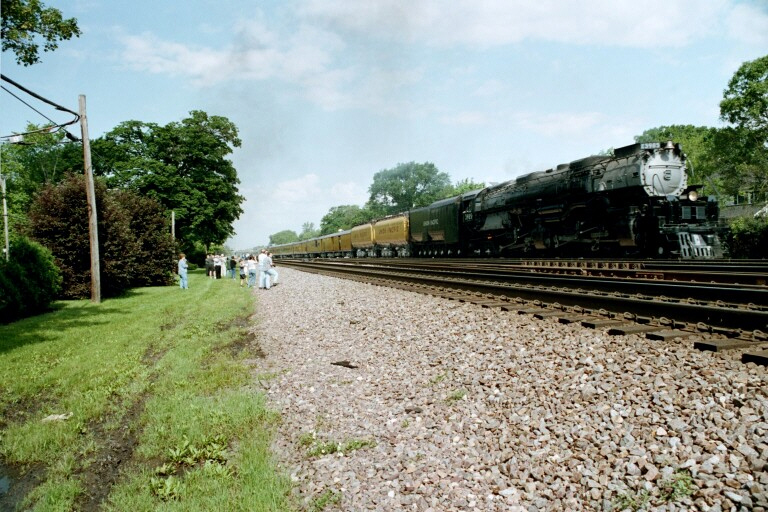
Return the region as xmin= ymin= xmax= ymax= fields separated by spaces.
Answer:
xmin=0 ymin=301 xmax=126 ymax=353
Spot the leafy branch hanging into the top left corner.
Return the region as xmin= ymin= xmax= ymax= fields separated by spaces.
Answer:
xmin=0 ymin=0 xmax=80 ymax=66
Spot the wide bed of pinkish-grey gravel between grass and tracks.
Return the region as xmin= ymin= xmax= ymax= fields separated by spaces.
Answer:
xmin=253 ymin=267 xmax=768 ymax=512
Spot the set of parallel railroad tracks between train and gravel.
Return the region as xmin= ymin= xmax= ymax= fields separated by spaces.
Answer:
xmin=281 ymin=260 xmax=768 ymax=365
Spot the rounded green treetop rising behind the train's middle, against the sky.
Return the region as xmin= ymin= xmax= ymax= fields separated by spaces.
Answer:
xmin=368 ymin=162 xmax=451 ymax=215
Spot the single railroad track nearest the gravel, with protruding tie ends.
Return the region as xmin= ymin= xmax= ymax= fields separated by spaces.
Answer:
xmin=282 ymin=265 xmax=768 ymax=366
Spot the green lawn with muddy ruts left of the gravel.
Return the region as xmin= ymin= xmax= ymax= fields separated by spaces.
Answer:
xmin=0 ymin=271 xmax=296 ymax=511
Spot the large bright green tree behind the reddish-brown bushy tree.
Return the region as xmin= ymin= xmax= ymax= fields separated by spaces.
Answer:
xmin=93 ymin=111 xmax=244 ymax=252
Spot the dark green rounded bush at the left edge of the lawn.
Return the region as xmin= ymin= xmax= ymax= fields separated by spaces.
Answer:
xmin=0 ymin=237 xmax=61 ymax=322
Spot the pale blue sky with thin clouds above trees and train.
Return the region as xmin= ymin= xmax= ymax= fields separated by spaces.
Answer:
xmin=0 ymin=0 xmax=768 ymax=249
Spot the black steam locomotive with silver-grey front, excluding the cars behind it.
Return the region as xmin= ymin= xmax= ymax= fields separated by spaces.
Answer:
xmin=463 ymin=142 xmax=721 ymax=258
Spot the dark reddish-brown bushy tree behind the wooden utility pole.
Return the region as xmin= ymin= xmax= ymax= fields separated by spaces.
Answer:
xmin=28 ymin=174 xmax=174 ymax=299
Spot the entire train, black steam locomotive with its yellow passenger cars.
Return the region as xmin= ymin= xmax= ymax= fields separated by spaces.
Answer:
xmin=270 ymin=141 xmax=723 ymax=259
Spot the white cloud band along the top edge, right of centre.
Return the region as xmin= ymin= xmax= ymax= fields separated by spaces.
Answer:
xmin=301 ymin=0 xmax=728 ymax=48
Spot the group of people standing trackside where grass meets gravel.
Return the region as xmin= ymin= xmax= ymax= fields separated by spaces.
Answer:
xmin=178 ymin=249 xmax=279 ymax=290
